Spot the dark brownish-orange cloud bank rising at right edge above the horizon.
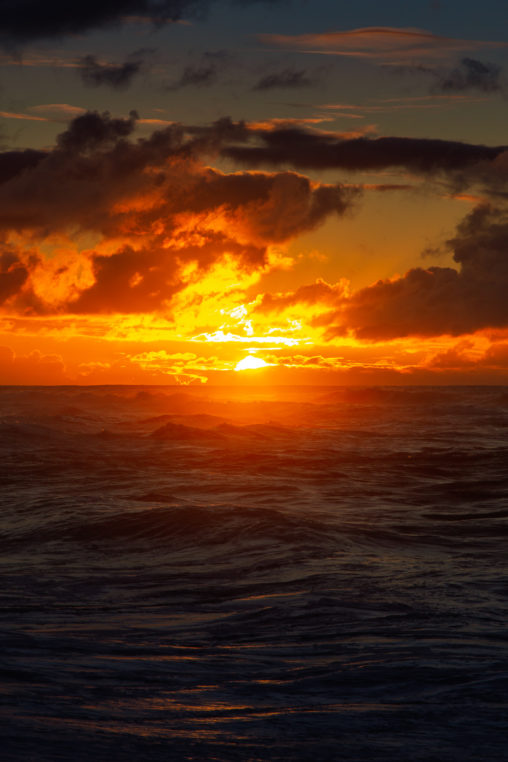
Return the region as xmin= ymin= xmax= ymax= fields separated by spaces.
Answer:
xmin=336 ymin=206 xmax=508 ymax=340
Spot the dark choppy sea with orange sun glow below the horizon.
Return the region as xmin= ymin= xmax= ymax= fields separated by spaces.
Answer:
xmin=0 ymin=387 xmax=508 ymax=762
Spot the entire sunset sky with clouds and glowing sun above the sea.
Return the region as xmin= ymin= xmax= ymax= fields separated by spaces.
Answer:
xmin=0 ymin=0 xmax=508 ymax=384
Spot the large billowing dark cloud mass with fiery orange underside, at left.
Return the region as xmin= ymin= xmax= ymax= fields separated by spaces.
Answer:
xmin=0 ymin=112 xmax=357 ymax=314
